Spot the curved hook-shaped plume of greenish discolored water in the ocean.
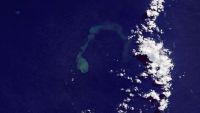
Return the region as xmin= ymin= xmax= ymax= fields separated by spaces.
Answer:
xmin=76 ymin=23 xmax=130 ymax=73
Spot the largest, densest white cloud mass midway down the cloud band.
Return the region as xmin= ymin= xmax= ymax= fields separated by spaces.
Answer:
xmin=134 ymin=37 xmax=173 ymax=90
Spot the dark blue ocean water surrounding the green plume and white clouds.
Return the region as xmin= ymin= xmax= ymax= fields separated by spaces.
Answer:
xmin=0 ymin=0 xmax=200 ymax=113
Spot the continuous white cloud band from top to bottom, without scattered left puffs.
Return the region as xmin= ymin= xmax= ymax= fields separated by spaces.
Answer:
xmin=133 ymin=0 xmax=174 ymax=111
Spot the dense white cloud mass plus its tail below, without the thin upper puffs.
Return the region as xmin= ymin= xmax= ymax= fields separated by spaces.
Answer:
xmin=134 ymin=36 xmax=174 ymax=111
